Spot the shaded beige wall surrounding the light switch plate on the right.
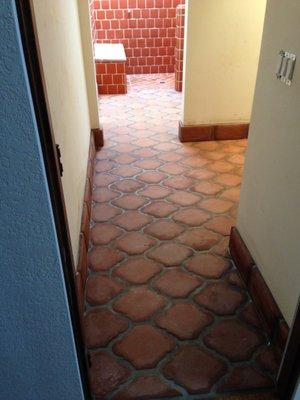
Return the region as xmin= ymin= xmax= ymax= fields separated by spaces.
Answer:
xmin=237 ymin=0 xmax=300 ymax=324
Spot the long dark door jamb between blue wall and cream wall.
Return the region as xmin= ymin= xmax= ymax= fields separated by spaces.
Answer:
xmin=16 ymin=0 xmax=91 ymax=400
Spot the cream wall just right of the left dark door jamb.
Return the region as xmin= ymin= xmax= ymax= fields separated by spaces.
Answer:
xmin=32 ymin=0 xmax=96 ymax=262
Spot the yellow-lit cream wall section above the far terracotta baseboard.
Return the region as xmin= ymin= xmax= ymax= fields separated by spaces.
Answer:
xmin=183 ymin=0 xmax=266 ymax=125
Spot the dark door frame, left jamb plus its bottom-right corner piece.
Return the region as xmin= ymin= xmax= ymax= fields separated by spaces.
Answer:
xmin=15 ymin=0 xmax=300 ymax=400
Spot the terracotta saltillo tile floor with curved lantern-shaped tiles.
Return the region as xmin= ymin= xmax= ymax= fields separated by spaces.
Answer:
xmin=85 ymin=74 xmax=278 ymax=399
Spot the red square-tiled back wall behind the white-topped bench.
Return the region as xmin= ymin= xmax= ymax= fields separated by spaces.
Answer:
xmin=90 ymin=0 xmax=185 ymax=74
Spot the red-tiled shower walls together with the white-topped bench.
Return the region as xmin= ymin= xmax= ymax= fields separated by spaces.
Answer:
xmin=89 ymin=0 xmax=185 ymax=95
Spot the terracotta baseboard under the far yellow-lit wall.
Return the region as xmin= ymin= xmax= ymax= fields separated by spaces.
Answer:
xmin=179 ymin=121 xmax=249 ymax=142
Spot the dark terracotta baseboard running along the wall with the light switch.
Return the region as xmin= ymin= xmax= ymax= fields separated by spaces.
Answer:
xmin=229 ymin=227 xmax=289 ymax=351
